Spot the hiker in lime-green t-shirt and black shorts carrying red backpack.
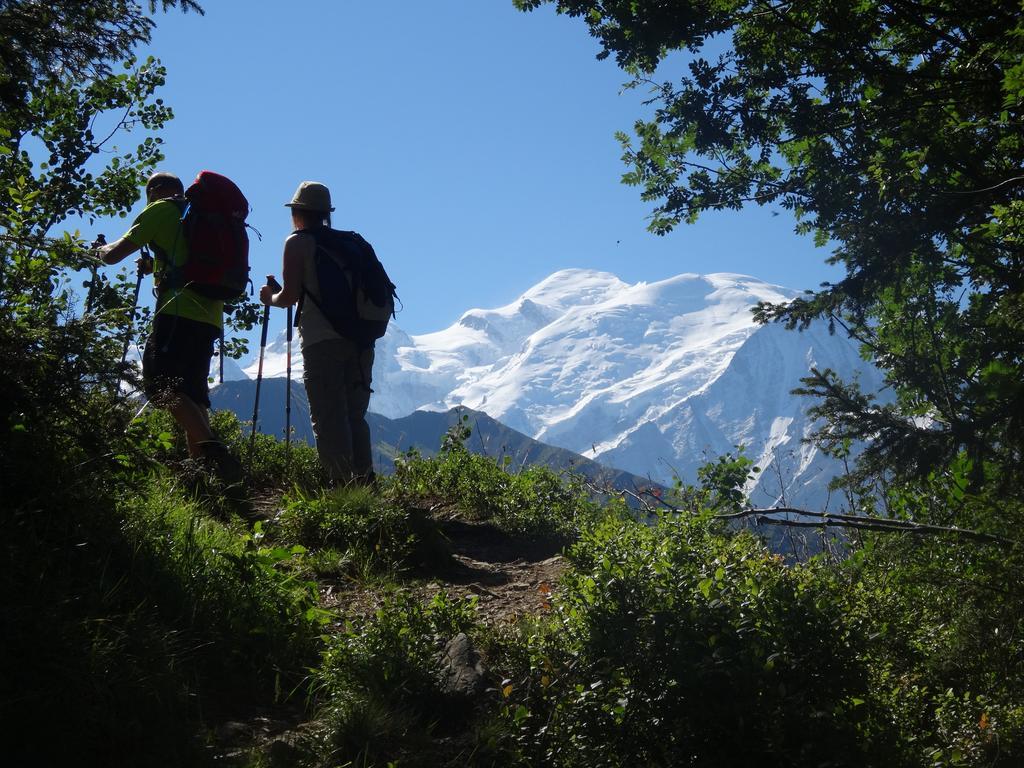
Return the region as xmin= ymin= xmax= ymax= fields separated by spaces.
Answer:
xmin=97 ymin=171 xmax=249 ymax=484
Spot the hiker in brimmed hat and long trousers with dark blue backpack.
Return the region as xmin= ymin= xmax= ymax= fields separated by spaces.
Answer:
xmin=260 ymin=181 xmax=395 ymax=486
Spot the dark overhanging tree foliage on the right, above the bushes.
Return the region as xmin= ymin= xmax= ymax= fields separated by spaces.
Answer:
xmin=517 ymin=0 xmax=1024 ymax=507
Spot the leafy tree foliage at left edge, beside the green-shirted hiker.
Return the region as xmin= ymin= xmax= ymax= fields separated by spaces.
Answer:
xmin=0 ymin=0 xmax=268 ymax=503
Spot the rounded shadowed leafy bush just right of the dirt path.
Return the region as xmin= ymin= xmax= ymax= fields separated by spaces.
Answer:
xmin=495 ymin=517 xmax=869 ymax=766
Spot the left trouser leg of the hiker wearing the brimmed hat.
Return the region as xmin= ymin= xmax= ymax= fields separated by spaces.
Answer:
xmin=302 ymin=339 xmax=352 ymax=483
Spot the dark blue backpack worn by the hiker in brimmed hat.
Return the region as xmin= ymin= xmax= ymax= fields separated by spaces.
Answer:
xmin=295 ymin=226 xmax=397 ymax=349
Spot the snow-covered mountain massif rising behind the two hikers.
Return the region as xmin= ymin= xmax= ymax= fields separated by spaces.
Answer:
xmin=235 ymin=269 xmax=882 ymax=506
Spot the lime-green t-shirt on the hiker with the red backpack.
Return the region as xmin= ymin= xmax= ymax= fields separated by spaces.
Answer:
xmin=125 ymin=200 xmax=224 ymax=328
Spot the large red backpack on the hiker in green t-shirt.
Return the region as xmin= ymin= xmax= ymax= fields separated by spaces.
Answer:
xmin=170 ymin=171 xmax=249 ymax=301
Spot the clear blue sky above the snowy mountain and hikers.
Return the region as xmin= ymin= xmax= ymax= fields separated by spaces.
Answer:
xmin=108 ymin=0 xmax=839 ymax=333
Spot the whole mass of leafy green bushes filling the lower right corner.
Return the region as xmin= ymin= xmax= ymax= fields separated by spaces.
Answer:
xmin=490 ymin=481 xmax=1024 ymax=768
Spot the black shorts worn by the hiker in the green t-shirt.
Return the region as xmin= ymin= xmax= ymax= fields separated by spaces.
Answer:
xmin=142 ymin=314 xmax=220 ymax=408
